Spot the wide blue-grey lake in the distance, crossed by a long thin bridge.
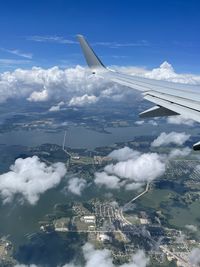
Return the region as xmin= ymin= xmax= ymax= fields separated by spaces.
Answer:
xmin=0 ymin=124 xmax=195 ymax=149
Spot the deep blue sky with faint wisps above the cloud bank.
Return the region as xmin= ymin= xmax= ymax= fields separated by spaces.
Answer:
xmin=0 ymin=0 xmax=200 ymax=73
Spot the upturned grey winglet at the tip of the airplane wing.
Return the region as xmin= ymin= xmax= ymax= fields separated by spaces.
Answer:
xmin=77 ymin=34 xmax=106 ymax=69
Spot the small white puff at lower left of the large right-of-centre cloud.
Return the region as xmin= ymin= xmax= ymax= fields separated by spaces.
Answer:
xmin=94 ymin=172 xmax=120 ymax=189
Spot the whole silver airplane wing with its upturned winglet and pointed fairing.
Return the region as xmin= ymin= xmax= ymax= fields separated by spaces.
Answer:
xmin=77 ymin=35 xmax=200 ymax=150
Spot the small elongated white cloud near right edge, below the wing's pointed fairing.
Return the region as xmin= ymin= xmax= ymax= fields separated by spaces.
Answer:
xmin=151 ymin=132 xmax=190 ymax=147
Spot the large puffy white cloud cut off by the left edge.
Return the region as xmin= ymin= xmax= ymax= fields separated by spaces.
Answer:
xmin=0 ymin=156 xmax=66 ymax=205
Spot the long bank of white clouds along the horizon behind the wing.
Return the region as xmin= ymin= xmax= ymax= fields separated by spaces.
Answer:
xmin=0 ymin=61 xmax=200 ymax=107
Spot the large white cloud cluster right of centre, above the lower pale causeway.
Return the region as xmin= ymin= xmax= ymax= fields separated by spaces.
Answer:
xmin=94 ymin=147 xmax=166 ymax=190
